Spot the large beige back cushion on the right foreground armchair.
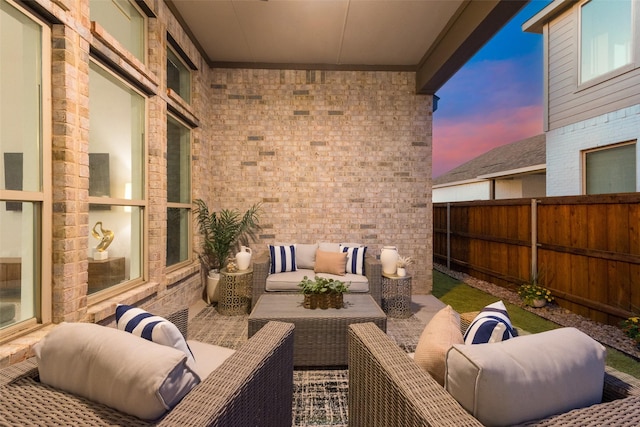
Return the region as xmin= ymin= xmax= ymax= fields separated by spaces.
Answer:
xmin=445 ymin=328 xmax=606 ymax=426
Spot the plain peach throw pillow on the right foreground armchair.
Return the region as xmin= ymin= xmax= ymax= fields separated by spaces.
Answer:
xmin=413 ymin=305 xmax=464 ymax=386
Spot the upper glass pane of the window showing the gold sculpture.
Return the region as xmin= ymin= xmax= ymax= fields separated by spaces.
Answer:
xmin=89 ymin=63 xmax=145 ymax=200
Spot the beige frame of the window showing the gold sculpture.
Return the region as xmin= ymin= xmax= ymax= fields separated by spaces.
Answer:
xmin=87 ymin=56 xmax=149 ymax=306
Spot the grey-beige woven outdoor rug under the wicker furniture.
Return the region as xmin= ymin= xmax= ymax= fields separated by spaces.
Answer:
xmin=189 ymin=306 xmax=425 ymax=426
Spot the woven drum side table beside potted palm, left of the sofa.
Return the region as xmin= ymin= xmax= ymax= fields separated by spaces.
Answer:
xmin=218 ymin=267 xmax=253 ymax=316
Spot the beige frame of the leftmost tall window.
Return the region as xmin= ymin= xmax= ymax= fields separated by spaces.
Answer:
xmin=0 ymin=0 xmax=53 ymax=342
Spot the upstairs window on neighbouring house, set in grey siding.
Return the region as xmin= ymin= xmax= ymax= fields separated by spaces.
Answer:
xmin=580 ymin=0 xmax=633 ymax=83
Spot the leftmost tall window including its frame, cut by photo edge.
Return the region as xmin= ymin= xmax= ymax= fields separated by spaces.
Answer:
xmin=0 ymin=0 xmax=51 ymax=335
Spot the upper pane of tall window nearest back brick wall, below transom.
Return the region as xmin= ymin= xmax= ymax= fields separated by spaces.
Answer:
xmin=167 ymin=117 xmax=191 ymax=203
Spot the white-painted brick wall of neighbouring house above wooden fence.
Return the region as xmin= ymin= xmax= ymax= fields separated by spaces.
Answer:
xmin=546 ymin=105 xmax=640 ymax=196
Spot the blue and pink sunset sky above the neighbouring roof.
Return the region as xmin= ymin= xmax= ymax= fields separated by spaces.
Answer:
xmin=433 ymin=0 xmax=549 ymax=178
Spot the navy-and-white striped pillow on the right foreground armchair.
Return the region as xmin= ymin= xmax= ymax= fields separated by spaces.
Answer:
xmin=464 ymin=301 xmax=518 ymax=344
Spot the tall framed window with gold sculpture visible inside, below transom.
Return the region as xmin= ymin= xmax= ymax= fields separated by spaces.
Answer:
xmin=87 ymin=61 xmax=146 ymax=295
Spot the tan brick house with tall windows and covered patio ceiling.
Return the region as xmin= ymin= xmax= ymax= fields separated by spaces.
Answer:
xmin=0 ymin=0 xmax=527 ymax=360
